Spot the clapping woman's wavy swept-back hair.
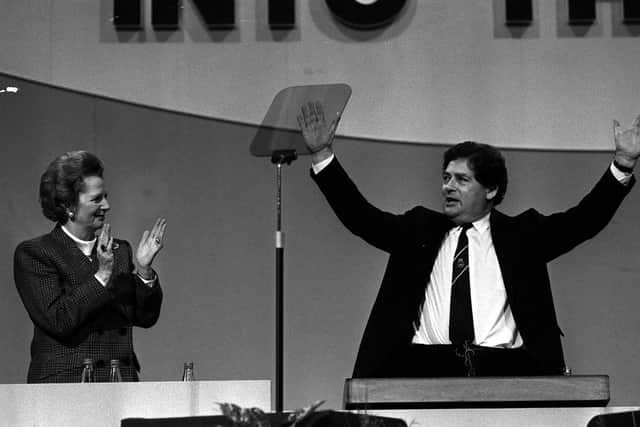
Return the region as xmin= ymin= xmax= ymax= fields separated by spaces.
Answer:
xmin=40 ymin=151 xmax=104 ymax=224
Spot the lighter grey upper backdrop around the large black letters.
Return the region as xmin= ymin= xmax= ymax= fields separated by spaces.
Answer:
xmin=0 ymin=0 xmax=640 ymax=150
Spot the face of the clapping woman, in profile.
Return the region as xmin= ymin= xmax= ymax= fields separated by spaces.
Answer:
xmin=71 ymin=176 xmax=109 ymax=238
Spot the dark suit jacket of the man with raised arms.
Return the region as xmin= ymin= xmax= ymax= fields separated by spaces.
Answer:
xmin=311 ymin=159 xmax=634 ymax=378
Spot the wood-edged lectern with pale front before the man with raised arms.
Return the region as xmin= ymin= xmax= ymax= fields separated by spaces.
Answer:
xmin=344 ymin=375 xmax=640 ymax=427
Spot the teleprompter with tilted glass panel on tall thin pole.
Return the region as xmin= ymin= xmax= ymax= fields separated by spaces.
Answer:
xmin=250 ymin=84 xmax=351 ymax=413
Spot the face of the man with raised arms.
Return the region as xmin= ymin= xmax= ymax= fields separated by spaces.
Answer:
xmin=442 ymin=159 xmax=497 ymax=224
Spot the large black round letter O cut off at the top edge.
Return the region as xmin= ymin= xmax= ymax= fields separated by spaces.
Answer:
xmin=325 ymin=0 xmax=406 ymax=30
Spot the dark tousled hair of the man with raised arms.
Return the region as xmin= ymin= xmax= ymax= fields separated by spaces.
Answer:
xmin=442 ymin=141 xmax=507 ymax=206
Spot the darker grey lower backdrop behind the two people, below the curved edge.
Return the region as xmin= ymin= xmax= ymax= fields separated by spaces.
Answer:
xmin=0 ymin=72 xmax=640 ymax=408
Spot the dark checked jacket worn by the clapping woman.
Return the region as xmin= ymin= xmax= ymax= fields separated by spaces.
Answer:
xmin=14 ymin=225 xmax=162 ymax=383
